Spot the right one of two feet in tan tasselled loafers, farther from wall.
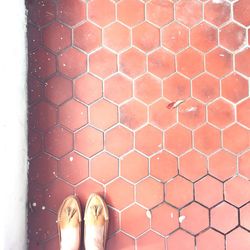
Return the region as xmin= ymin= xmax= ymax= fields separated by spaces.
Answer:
xmin=84 ymin=194 xmax=109 ymax=250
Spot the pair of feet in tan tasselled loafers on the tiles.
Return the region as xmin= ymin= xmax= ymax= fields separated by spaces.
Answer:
xmin=57 ymin=194 xmax=109 ymax=250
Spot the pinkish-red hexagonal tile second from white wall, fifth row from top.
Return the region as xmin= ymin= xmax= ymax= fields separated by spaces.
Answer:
xmin=59 ymin=99 xmax=88 ymax=131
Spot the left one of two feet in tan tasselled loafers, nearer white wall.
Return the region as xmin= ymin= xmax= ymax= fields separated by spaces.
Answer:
xmin=57 ymin=195 xmax=82 ymax=250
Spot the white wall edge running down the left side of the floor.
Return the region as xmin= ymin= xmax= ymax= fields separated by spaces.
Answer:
xmin=0 ymin=0 xmax=28 ymax=250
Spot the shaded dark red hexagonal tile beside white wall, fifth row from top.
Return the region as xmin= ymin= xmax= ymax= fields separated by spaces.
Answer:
xmin=29 ymin=102 xmax=57 ymax=130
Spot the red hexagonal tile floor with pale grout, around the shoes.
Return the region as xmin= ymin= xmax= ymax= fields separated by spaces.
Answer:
xmin=26 ymin=0 xmax=250 ymax=250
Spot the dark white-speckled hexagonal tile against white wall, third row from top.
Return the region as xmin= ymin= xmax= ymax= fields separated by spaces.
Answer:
xmin=29 ymin=48 xmax=56 ymax=79
